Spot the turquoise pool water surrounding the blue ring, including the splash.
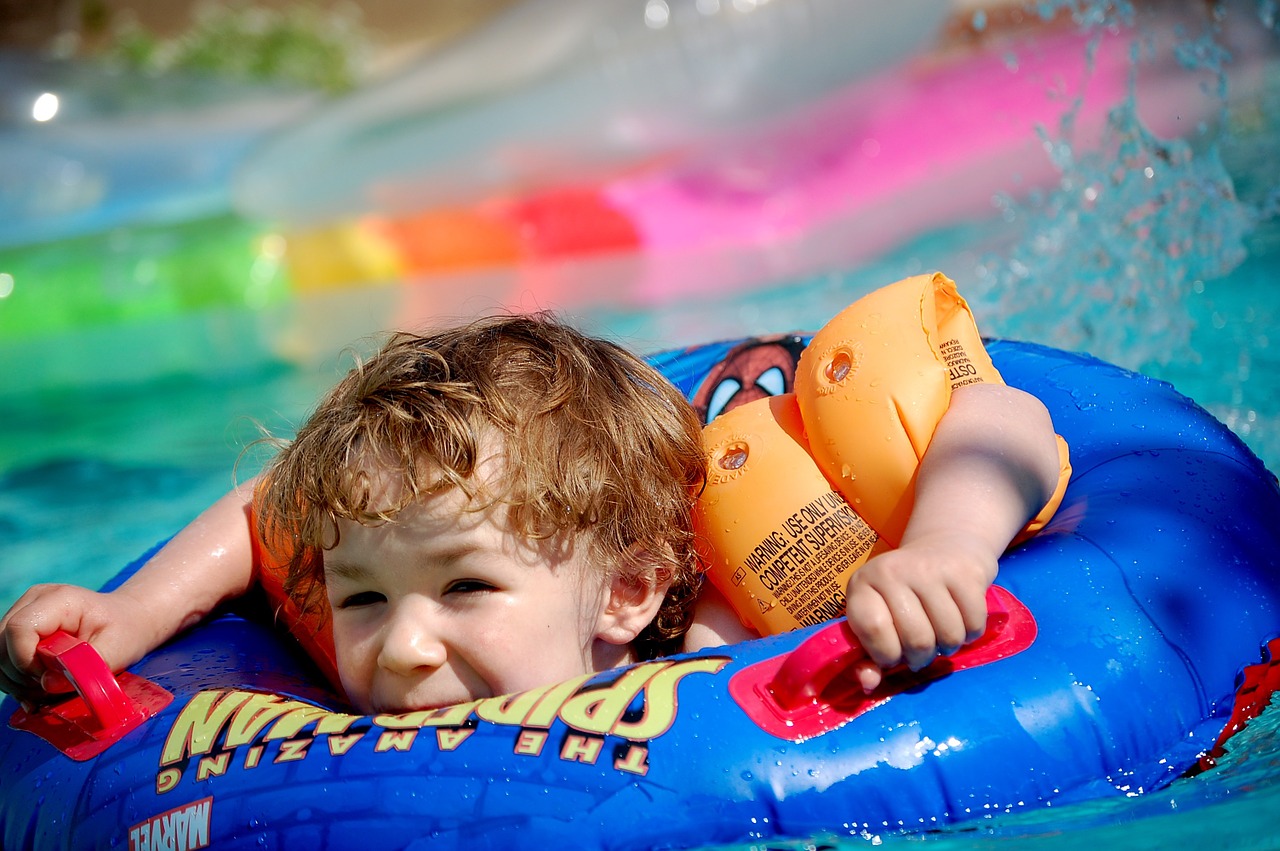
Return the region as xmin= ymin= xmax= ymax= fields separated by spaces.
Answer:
xmin=0 ymin=1 xmax=1280 ymax=848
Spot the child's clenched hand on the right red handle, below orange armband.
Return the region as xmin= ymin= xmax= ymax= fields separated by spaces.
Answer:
xmin=846 ymin=532 xmax=1000 ymax=692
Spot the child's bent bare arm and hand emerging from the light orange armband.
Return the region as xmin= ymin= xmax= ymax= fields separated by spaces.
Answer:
xmin=846 ymin=384 xmax=1060 ymax=691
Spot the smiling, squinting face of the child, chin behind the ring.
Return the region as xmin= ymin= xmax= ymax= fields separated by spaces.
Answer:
xmin=325 ymin=468 xmax=609 ymax=713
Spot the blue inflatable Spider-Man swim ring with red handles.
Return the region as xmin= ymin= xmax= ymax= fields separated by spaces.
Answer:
xmin=0 ymin=342 xmax=1280 ymax=851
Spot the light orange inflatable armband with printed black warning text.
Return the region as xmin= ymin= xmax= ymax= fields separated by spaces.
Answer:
xmin=695 ymin=274 xmax=1071 ymax=633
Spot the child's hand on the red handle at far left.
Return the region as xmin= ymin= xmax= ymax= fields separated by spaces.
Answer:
xmin=0 ymin=585 xmax=156 ymax=705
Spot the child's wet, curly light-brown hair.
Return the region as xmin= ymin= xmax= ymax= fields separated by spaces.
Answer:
xmin=255 ymin=314 xmax=705 ymax=658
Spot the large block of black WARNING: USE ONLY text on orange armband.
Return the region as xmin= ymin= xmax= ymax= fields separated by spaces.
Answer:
xmin=737 ymin=491 xmax=877 ymax=624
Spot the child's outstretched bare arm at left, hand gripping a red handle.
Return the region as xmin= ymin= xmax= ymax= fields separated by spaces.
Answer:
xmin=0 ymin=481 xmax=255 ymax=703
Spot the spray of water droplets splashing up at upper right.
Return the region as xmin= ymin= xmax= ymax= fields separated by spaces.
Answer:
xmin=984 ymin=0 xmax=1280 ymax=369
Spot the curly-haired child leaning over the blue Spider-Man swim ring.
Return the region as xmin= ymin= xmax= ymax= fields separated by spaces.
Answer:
xmin=0 ymin=308 xmax=1059 ymax=712
